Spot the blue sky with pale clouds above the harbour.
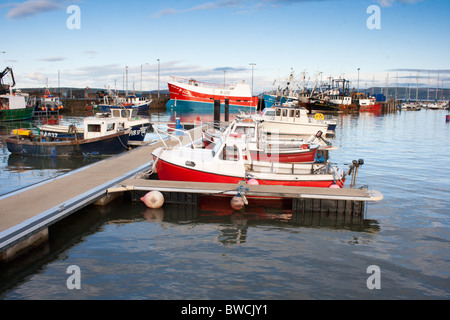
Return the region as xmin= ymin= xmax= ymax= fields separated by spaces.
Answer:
xmin=0 ymin=0 xmax=450 ymax=93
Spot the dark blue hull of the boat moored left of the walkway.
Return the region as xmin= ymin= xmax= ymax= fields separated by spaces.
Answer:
xmin=5 ymin=132 xmax=129 ymax=157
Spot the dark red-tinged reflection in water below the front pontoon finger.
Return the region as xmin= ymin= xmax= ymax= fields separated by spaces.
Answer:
xmin=138 ymin=197 xmax=380 ymax=240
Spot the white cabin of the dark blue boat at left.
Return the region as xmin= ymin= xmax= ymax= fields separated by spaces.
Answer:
xmin=83 ymin=113 xmax=124 ymax=139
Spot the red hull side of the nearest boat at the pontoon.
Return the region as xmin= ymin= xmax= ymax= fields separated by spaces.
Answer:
xmin=156 ymin=159 xmax=345 ymax=188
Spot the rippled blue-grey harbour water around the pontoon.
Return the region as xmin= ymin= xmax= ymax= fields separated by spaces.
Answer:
xmin=0 ymin=109 xmax=450 ymax=300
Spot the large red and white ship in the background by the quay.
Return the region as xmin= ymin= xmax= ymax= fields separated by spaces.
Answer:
xmin=168 ymin=77 xmax=258 ymax=108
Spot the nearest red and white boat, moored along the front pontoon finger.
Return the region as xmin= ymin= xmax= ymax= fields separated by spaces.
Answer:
xmin=153 ymin=132 xmax=346 ymax=188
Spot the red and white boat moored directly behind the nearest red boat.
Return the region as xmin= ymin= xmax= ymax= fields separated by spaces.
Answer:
xmin=203 ymin=119 xmax=331 ymax=163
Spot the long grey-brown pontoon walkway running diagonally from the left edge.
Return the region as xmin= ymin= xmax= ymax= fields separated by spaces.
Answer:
xmin=0 ymin=127 xmax=206 ymax=260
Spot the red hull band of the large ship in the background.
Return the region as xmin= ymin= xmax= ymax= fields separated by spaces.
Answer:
xmin=168 ymin=83 xmax=259 ymax=107
